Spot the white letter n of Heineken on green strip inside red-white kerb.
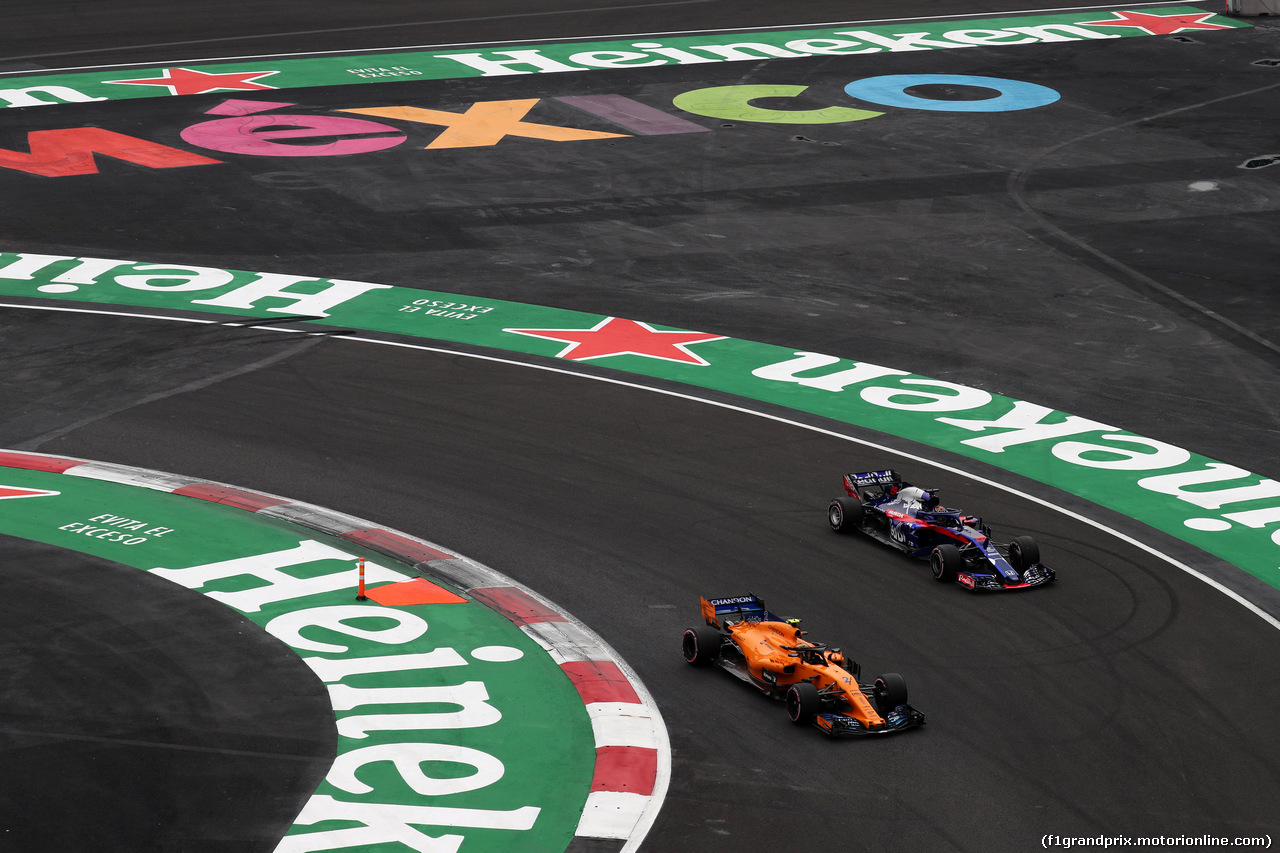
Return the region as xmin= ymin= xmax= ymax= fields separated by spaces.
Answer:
xmin=329 ymin=681 xmax=502 ymax=738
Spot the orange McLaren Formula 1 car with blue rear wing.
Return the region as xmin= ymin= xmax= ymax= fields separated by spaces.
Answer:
xmin=682 ymin=594 xmax=924 ymax=735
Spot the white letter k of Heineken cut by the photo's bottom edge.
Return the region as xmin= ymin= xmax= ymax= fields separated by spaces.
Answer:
xmin=275 ymin=794 xmax=541 ymax=853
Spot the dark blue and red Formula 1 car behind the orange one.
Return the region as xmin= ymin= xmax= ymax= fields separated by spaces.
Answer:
xmin=827 ymin=471 xmax=1057 ymax=590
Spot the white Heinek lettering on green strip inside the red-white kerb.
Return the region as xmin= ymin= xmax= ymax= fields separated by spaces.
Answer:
xmin=135 ymin=535 xmax=555 ymax=853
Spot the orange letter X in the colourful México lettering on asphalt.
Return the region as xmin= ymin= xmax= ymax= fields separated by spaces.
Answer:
xmin=339 ymin=97 xmax=626 ymax=149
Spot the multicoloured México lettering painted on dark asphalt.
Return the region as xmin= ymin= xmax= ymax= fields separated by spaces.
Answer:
xmin=0 ymin=74 xmax=1059 ymax=178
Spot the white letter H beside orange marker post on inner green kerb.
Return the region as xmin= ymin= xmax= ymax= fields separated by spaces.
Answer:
xmin=151 ymin=539 xmax=403 ymax=613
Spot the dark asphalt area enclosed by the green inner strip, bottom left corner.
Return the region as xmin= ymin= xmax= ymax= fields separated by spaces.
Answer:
xmin=0 ymin=527 xmax=337 ymax=853
